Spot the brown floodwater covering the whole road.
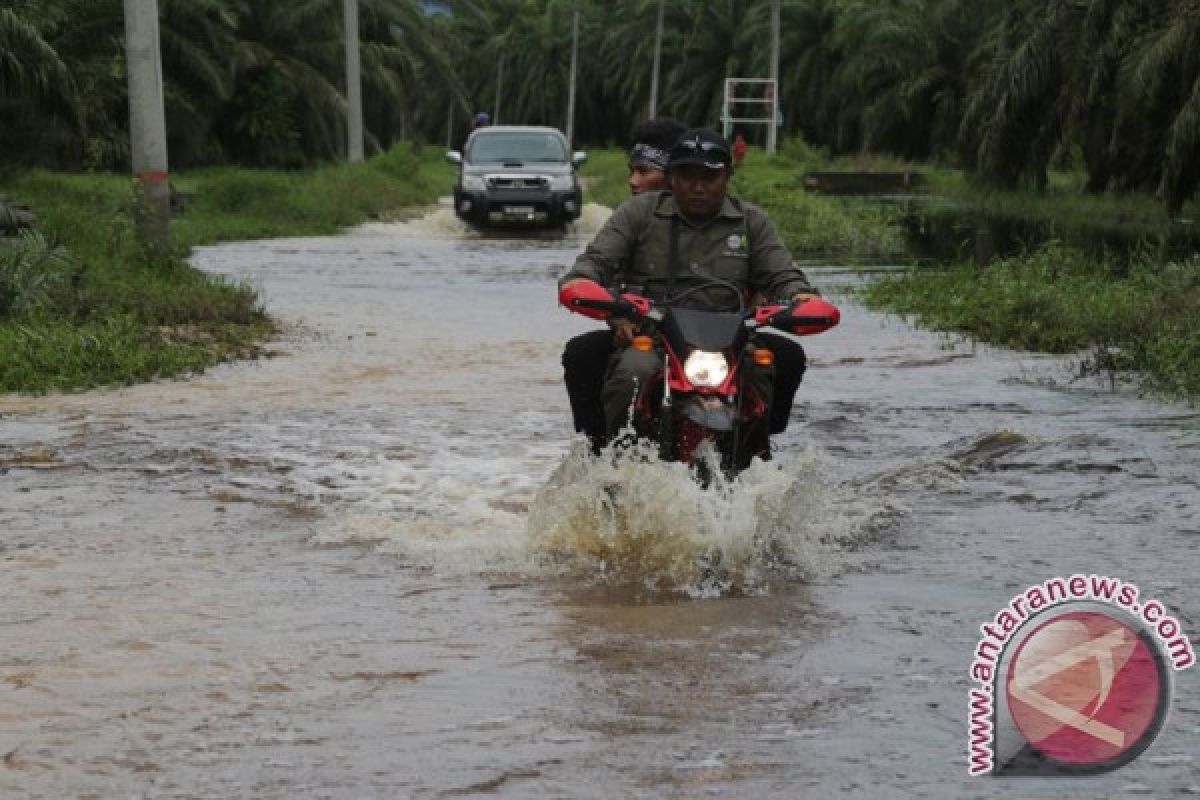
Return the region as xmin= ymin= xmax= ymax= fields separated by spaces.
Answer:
xmin=0 ymin=203 xmax=1200 ymax=800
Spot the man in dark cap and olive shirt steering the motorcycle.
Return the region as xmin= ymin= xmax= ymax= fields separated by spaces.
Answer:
xmin=559 ymin=130 xmax=818 ymax=437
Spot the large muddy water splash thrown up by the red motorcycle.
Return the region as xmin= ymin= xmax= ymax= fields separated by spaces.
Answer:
xmin=528 ymin=445 xmax=859 ymax=596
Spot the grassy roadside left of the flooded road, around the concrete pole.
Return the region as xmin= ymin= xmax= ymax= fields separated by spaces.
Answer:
xmin=0 ymin=146 xmax=452 ymax=392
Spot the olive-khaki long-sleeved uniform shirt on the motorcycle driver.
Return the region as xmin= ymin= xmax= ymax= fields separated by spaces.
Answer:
xmin=559 ymin=191 xmax=816 ymax=311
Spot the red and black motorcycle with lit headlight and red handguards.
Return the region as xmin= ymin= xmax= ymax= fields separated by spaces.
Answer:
xmin=559 ymin=281 xmax=841 ymax=483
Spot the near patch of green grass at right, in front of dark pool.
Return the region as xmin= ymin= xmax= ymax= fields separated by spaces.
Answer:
xmin=865 ymin=243 xmax=1200 ymax=402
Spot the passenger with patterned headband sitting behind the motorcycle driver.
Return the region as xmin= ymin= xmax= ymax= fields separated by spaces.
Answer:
xmin=563 ymin=116 xmax=688 ymax=450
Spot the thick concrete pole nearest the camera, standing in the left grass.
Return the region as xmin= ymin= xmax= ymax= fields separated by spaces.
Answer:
xmin=125 ymin=0 xmax=170 ymax=253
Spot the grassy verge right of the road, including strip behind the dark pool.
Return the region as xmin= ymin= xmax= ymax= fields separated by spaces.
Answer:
xmin=865 ymin=169 xmax=1200 ymax=403
